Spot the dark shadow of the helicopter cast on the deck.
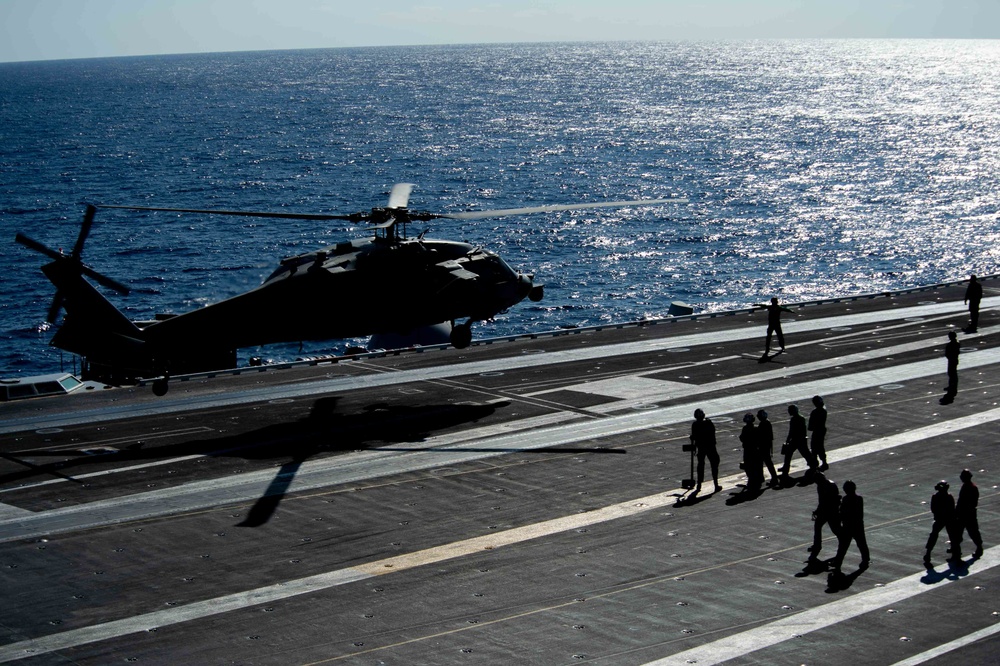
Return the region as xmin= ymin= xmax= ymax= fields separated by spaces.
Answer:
xmin=0 ymin=397 xmax=624 ymax=527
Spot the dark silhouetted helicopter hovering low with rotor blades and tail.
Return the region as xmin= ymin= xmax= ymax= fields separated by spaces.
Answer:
xmin=15 ymin=183 xmax=684 ymax=395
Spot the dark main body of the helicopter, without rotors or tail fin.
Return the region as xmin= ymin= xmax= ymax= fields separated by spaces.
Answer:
xmin=142 ymin=238 xmax=540 ymax=357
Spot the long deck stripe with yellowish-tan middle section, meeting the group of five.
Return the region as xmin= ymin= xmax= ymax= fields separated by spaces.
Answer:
xmin=0 ymin=407 xmax=1000 ymax=663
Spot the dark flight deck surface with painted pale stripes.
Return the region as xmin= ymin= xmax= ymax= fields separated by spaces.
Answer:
xmin=0 ymin=281 xmax=1000 ymax=664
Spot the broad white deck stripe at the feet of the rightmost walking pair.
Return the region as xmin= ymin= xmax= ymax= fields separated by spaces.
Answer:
xmin=646 ymin=546 xmax=1000 ymax=666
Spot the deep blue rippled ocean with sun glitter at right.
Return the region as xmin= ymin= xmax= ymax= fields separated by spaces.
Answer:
xmin=0 ymin=40 xmax=1000 ymax=376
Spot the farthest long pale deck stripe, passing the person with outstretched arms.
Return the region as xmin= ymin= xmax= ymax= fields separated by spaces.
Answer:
xmin=0 ymin=296 xmax=1000 ymax=434
